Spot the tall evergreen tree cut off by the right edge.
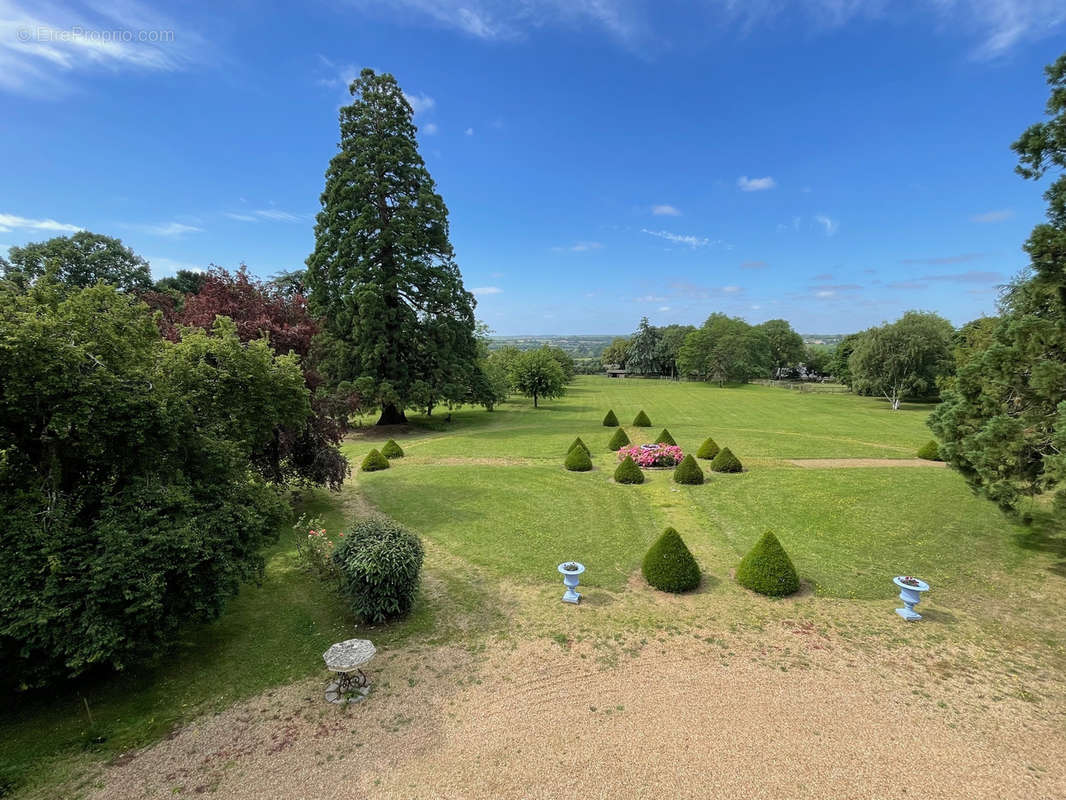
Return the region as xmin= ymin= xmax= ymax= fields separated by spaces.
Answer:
xmin=930 ymin=54 xmax=1066 ymax=518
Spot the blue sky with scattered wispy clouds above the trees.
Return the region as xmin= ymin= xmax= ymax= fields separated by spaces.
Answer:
xmin=0 ymin=0 xmax=1066 ymax=334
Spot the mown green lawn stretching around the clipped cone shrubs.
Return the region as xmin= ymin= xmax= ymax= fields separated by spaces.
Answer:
xmin=0 ymin=378 xmax=1066 ymax=797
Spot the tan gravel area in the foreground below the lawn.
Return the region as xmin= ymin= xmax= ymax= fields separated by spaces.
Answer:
xmin=87 ymin=629 xmax=1066 ymax=800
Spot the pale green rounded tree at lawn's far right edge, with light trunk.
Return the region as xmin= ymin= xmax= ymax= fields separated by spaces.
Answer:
xmin=849 ymin=311 xmax=954 ymax=410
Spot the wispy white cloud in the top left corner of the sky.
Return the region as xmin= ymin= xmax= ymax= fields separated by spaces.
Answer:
xmin=0 ymin=0 xmax=208 ymax=96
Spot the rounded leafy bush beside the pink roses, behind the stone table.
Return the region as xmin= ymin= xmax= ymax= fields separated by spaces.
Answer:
xmin=334 ymin=517 xmax=423 ymax=625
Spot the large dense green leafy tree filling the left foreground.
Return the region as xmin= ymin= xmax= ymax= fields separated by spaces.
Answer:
xmin=0 ymin=282 xmax=310 ymax=686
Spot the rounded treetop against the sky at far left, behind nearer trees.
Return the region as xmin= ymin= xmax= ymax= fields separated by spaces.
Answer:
xmin=0 ymin=230 xmax=151 ymax=291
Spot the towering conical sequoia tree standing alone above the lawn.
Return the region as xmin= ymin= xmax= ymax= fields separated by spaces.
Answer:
xmin=306 ymin=69 xmax=478 ymax=425
